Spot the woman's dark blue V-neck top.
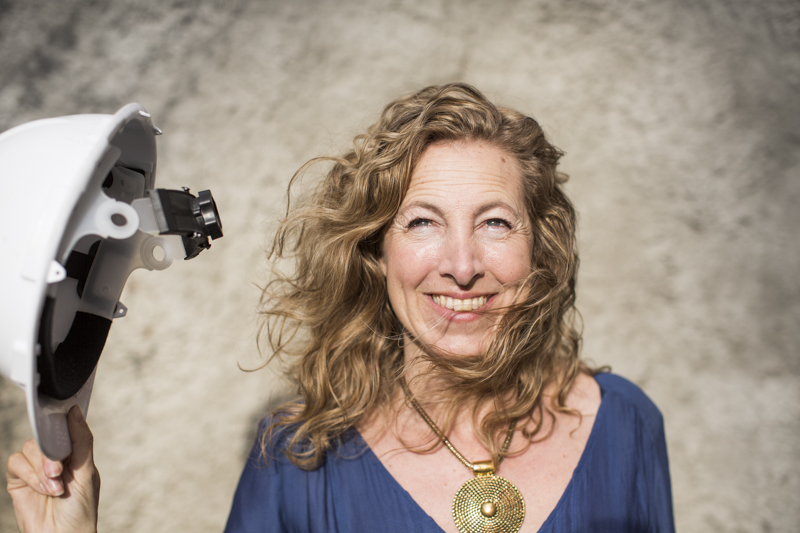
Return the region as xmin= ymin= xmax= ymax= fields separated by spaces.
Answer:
xmin=225 ymin=374 xmax=675 ymax=533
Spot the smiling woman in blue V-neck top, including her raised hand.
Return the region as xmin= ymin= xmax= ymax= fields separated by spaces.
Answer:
xmin=9 ymin=84 xmax=673 ymax=532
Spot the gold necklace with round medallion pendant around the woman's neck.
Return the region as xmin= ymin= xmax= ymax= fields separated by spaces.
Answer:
xmin=401 ymin=382 xmax=525 ymax=533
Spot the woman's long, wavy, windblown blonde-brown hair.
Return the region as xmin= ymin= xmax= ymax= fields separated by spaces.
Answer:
xmin=261 ymin=83 xmax=590 ymax=469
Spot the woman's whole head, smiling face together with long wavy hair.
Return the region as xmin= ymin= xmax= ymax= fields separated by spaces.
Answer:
xmin=263 ymin=84 xmax=590 ymax=468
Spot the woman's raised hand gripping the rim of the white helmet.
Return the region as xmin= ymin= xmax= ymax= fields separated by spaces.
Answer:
xmin=6 ymin=405 xmax=100 ymax=533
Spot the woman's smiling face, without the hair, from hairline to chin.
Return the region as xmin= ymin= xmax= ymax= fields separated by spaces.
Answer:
xmin=381 ymin=141 xmax=533 ymax=356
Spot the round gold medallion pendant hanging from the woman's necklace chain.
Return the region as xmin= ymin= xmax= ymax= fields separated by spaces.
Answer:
xmin=453 ymin=461 xmax=525 ymax=533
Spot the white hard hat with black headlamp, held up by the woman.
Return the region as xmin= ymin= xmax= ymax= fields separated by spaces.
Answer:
xmin=0 ymin=104 xmax=222 ymax=460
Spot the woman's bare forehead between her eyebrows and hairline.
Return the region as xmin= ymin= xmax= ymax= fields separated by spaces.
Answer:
xmin=403 ymin=141 xmax=524 ymax=207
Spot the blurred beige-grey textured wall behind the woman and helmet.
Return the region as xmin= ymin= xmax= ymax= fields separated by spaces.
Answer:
xmin=0 ymin=0 xmax=800 ymax=533
